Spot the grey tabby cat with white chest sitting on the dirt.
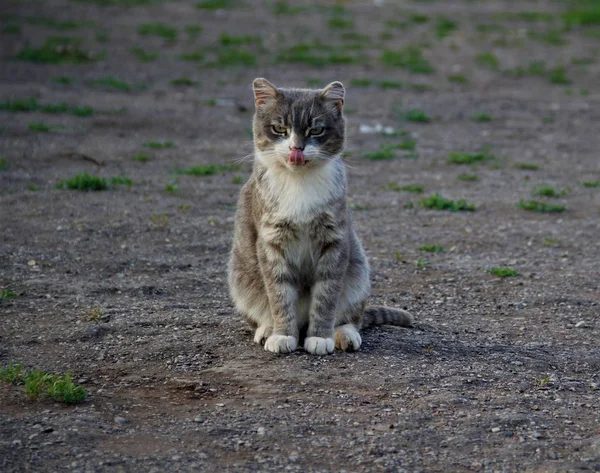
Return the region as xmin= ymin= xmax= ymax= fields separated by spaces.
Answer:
xmin=228 ymin=78 xmax=413 ymax=355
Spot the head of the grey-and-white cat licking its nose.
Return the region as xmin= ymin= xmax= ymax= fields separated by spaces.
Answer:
xmin=252 ymin=78 xmax=346 ymax=171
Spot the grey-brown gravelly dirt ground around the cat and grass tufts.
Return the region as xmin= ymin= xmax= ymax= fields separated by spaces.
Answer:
xmin=0 ymin=0 xmax=600 ymax=473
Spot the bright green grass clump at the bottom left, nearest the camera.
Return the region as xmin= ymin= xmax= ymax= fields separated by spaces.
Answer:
xmin=0 ymin=362 xmax=86 ymax=404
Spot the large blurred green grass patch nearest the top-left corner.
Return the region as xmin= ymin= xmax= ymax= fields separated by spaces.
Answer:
xmin=17 ymin=36 xmax=101 ymax=64
